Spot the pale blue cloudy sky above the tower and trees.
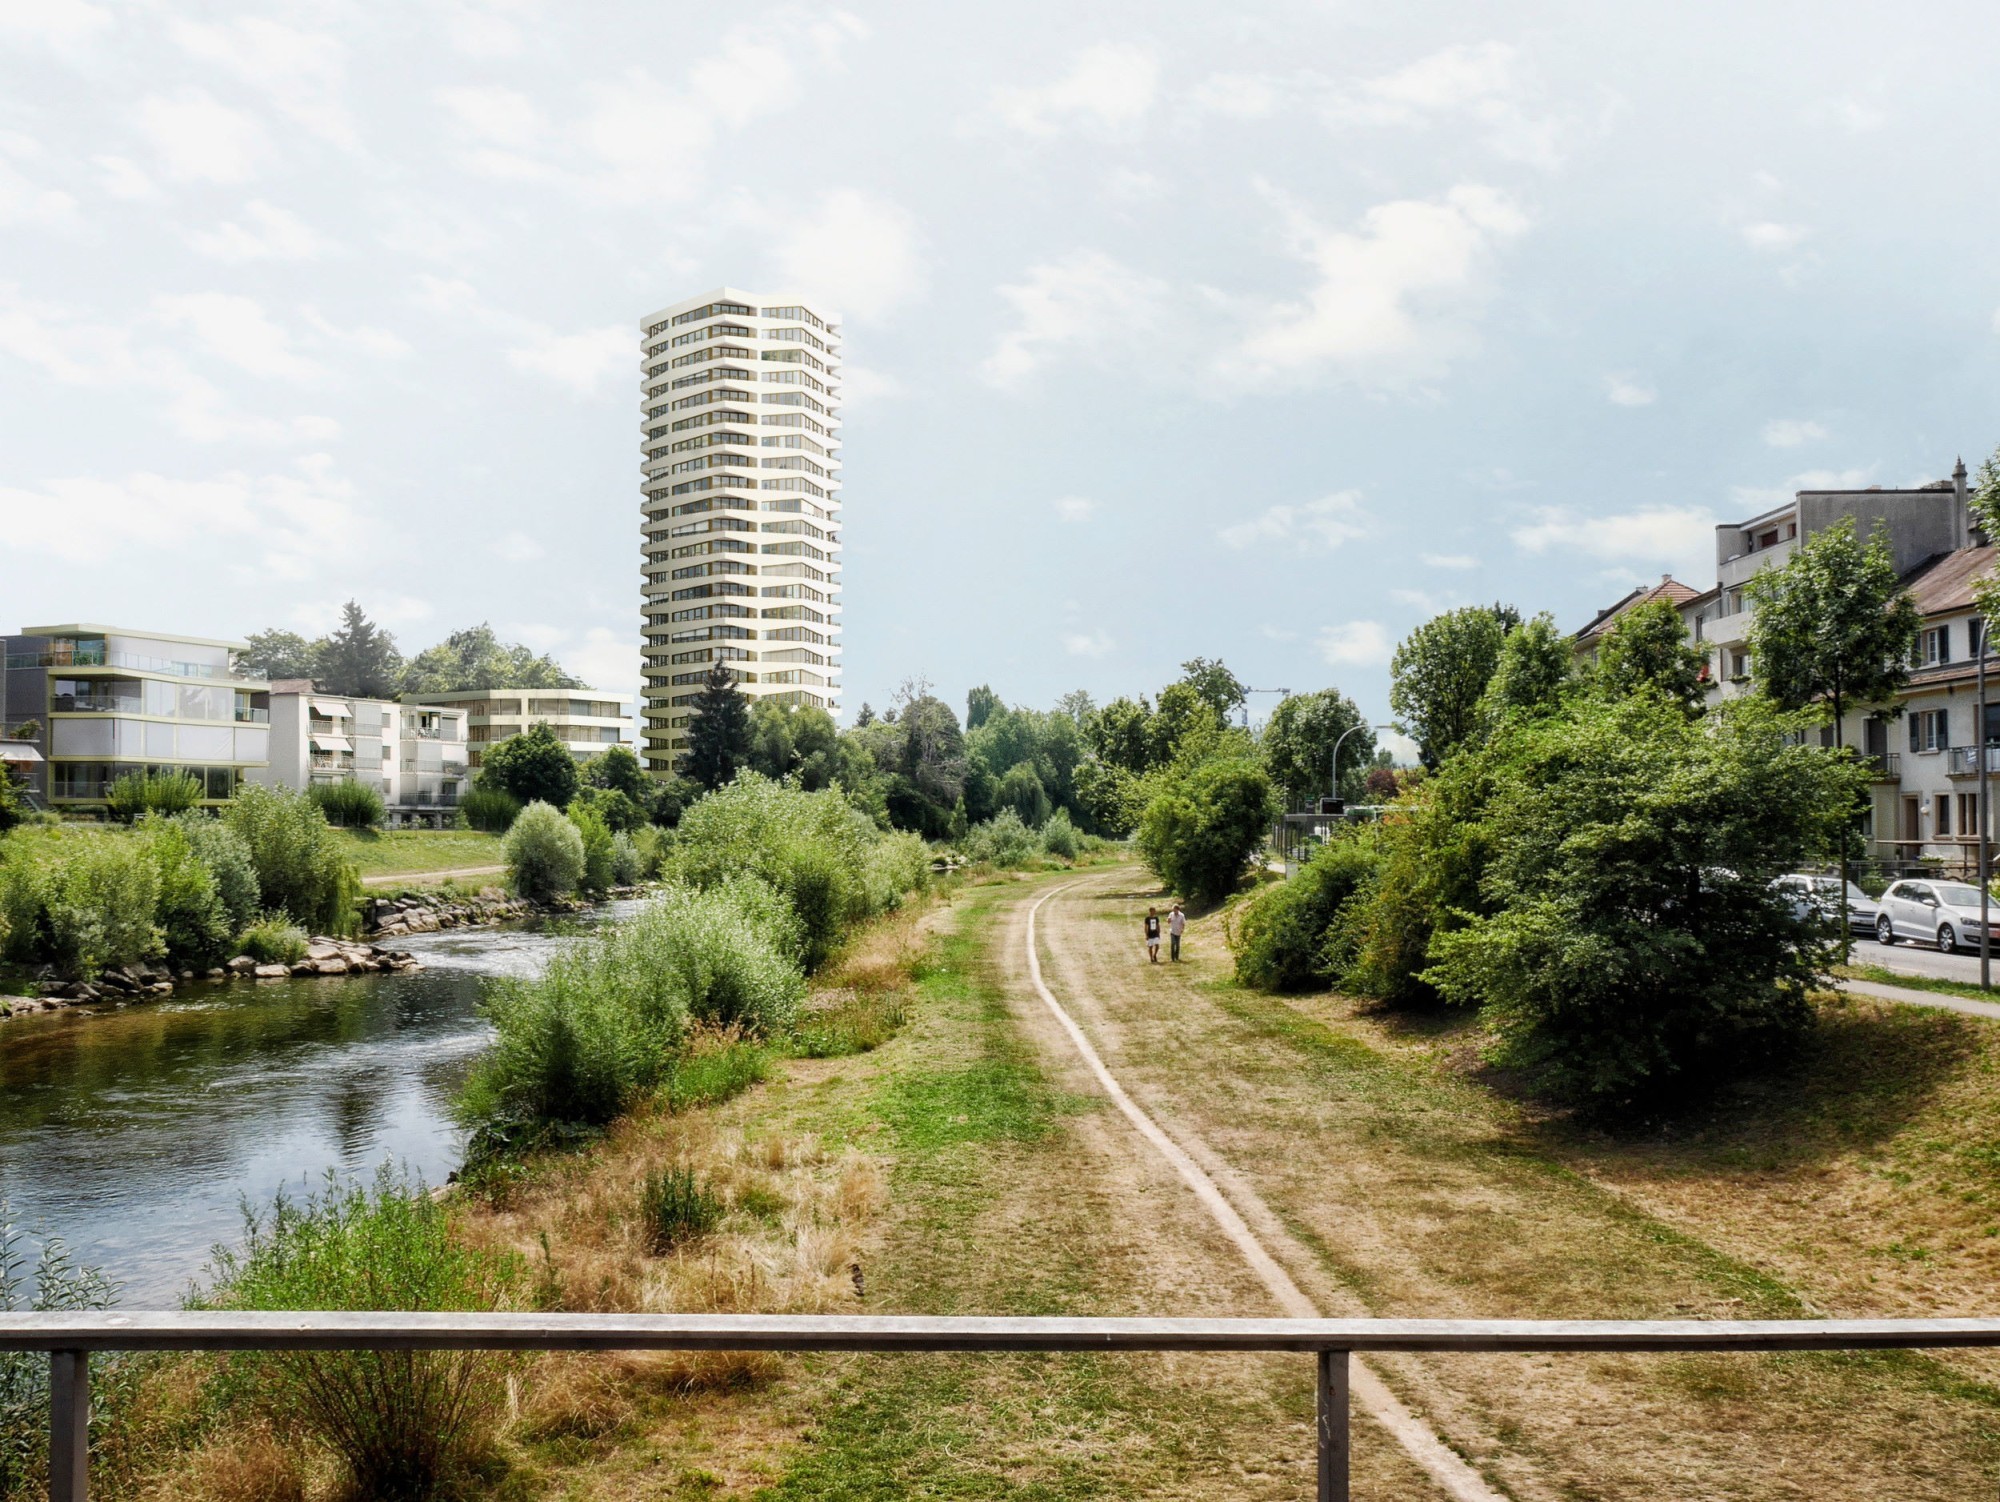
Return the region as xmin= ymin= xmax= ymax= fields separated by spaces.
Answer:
xmin=0 ymin=0 xmax=2000 ymax=716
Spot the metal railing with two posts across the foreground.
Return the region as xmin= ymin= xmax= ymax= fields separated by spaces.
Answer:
xmin=15 ymin=1310 xmax=2000 ymax=1502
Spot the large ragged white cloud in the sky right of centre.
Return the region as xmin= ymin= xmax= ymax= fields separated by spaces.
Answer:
xmin=1222 ymin=184 xmax=1528 ymax=380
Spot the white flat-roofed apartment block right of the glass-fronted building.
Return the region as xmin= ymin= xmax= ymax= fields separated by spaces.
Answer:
xmin=250 ymin=678 xmax=470 ymax=828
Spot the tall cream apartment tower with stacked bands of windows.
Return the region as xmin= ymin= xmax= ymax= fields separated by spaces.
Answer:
xmin=640 ymin=286 xmax=840 ymax=772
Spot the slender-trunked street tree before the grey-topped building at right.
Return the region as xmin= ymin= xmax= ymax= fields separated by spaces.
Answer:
xmin=1744 ymin=516 xmax=1920 ymax=746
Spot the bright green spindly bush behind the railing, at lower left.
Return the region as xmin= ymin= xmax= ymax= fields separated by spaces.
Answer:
xmin=194 ymin=1166 xmax=512 ymax=1502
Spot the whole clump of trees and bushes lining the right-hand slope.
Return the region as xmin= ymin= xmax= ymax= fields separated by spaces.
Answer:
xmin=1236 ymin=524 xmax=1916 ymax=1108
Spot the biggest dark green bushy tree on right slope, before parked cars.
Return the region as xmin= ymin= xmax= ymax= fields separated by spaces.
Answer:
xmin=1432 ymin=696 xmax=1866 ymax=1108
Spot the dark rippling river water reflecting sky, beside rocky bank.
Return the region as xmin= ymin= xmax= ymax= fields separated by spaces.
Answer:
xmin=0 ymin=904 xmax=626 ymax=1308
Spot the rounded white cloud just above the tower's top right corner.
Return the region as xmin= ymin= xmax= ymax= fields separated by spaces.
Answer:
xmin=766 ymin=188 xmax=926 ymax=318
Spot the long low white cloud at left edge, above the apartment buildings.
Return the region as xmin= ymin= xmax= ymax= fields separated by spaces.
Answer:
xmin=0 ymin=454 xmax=368 ymax=580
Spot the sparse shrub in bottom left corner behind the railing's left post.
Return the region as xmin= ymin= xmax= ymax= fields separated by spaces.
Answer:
xmin=0 ymin=1198 xmax=126 ymax=1498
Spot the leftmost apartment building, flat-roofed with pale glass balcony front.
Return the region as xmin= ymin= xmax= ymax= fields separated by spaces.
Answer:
xmin=0 ymin=624 xmax=270 ymax=810
